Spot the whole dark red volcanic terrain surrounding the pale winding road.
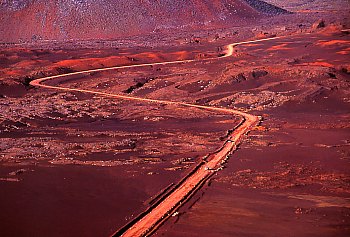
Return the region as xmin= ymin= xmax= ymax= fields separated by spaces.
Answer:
xmin=0 ymin=0 xmax=350 ymax=236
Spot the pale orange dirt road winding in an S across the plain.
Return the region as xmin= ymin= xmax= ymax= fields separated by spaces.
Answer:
xmin=30 ymin=37 xmax=280 ymax=237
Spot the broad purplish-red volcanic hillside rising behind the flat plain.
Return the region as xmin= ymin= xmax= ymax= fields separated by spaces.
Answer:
xmin=0 ymin=0 xmax=284 ymax=42
